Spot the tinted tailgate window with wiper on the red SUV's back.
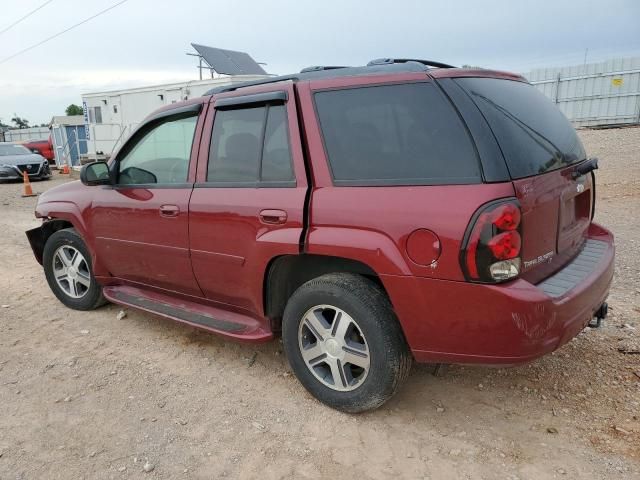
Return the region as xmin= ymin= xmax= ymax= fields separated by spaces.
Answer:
xmin=456 ymin=78 xmax=585 ymax=179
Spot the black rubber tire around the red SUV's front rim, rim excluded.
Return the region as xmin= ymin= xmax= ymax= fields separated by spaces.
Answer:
xmin=42 ymin=228 xmax=107 ymax=310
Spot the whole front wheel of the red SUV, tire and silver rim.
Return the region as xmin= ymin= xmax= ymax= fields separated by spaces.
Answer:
xmin=42 ymin=228 xmax=106 ymax=310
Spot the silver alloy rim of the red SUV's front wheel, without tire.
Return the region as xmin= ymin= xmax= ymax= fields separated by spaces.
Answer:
xmin=53 ymin=245 xmax=91 ymax=298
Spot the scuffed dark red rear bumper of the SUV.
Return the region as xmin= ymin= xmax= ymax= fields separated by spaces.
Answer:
xmin=382 ymin=224 xmax=615 ymax=364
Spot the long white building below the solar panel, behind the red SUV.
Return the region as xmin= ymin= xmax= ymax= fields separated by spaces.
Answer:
xmin=82 ymin=75 xmax=265 ymax=159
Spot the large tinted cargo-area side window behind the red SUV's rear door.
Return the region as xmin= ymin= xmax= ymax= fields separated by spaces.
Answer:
xmin=315 ymin=83 xmax=481 ymax=185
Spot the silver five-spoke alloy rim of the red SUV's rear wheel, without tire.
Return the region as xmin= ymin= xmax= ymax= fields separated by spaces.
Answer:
xmin=298 ymin=305 xmax=371 ymax=392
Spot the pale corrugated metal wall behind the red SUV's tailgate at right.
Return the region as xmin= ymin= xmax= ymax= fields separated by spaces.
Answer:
xmin=523 ymin=57 xmax=640 ymax=127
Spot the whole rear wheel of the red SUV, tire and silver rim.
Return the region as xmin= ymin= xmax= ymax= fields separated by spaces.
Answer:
xmin=282 ymin=274 xmax=412 ymax=413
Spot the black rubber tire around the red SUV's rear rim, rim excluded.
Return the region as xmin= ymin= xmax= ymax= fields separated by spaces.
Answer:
xmin=282 ymin=273 xmax=413 ymax=413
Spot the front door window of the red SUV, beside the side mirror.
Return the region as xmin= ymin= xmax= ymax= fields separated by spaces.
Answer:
xmin=118 ymin=116 xmax=198 ymax=184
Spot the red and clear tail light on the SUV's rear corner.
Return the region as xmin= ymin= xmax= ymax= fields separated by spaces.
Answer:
xmin=460 ymin=199 xmax=522 ymax=283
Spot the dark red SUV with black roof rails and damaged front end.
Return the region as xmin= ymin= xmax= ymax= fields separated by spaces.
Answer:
xmin=27 ymin=59 xmax=614 ymax=412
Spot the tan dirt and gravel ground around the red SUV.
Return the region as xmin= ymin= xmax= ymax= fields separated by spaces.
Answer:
xmin=0 ymin=128 xmax=640 ymax=480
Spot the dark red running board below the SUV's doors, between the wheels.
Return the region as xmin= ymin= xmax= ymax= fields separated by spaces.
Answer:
xmin=103 ymin=286 xmax=273 ymax=342
